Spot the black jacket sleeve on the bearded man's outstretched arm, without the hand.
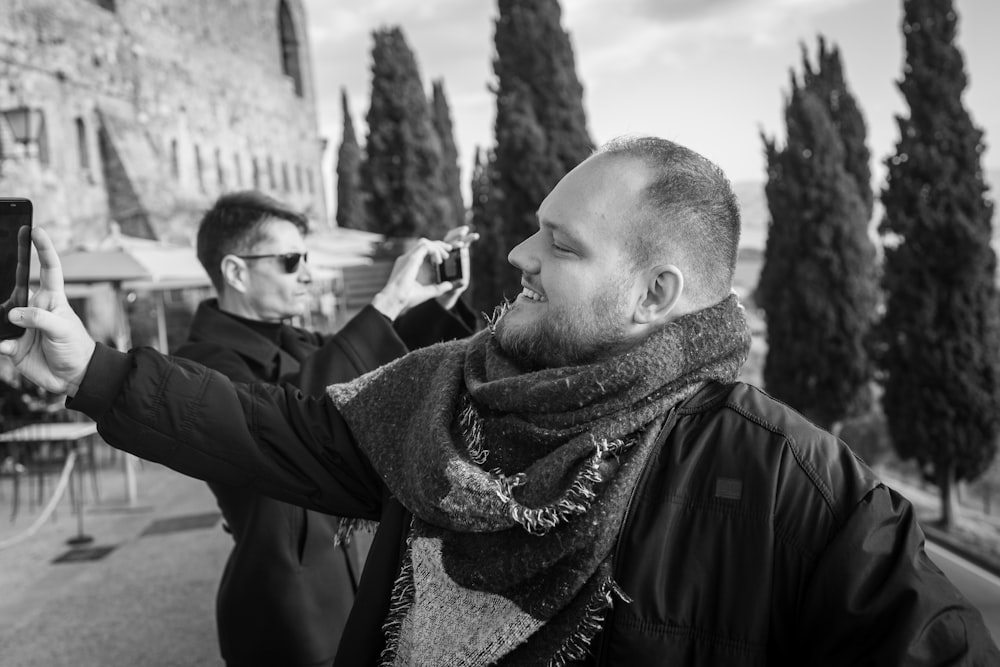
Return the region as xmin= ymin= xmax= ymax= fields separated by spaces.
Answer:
xmin=67 ymin=345 xmax=382 ymax=520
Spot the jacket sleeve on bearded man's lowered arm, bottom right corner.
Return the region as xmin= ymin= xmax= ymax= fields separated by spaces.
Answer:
xmin=792 ymin=485 xmax=1000 ymax=665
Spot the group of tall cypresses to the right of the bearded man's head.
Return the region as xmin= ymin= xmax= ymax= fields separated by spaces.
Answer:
xmin=755 ymin=0 xmax=1000 ymax=528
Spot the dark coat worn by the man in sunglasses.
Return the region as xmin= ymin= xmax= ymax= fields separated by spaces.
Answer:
xmin=175 ymin=299 xmax=468 ymax=666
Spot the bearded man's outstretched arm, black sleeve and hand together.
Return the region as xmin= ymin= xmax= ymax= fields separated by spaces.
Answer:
xmin=0 ymin=228 xmax=381 ymax=518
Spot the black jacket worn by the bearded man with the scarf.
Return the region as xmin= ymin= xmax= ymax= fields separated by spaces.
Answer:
xmin=71 ymin=347 xmax=1000 ymax=667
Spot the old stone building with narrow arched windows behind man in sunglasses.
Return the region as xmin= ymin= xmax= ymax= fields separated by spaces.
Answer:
xmin=0 ymin=0 xmax=327 ymax=248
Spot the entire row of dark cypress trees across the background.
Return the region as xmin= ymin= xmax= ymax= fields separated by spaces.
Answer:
xmin=337 ymin=0 xmax=1000 ymax=527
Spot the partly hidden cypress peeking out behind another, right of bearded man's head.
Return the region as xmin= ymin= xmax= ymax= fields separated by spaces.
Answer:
xmin=802 ymin=35 xmax=875 ymax=220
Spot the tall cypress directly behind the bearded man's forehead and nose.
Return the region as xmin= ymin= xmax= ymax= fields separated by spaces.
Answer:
xmin=490 ymin=0 xmax=593 ymax=301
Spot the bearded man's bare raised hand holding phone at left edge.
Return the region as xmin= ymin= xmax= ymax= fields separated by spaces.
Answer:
xmin=0 ymin=227 xmax=95 ymax=396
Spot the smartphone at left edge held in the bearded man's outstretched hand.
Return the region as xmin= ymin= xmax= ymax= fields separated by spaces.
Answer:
xmin=0 ymin=197 xmax=32 ymax=340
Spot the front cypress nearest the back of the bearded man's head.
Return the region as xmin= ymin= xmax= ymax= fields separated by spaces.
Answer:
xmin=757 ymin=77 xmax=878 ymax=430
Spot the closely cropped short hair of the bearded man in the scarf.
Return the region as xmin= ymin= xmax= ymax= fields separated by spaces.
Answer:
xmin=596 ymin=137 xmax=740 ymax=306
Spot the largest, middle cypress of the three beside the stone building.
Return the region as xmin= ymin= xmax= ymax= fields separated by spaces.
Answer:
xmin=361 ymin=27 xmax=447 ymax=238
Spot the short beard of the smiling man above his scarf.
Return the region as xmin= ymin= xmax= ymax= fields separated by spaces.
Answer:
xmin=491 ymin=294 xmax=626 ymax=370
